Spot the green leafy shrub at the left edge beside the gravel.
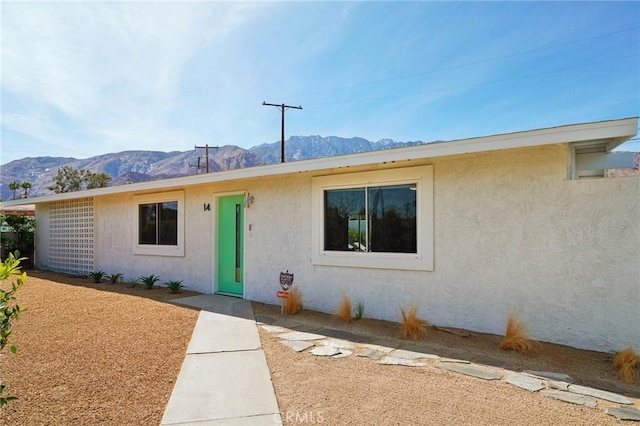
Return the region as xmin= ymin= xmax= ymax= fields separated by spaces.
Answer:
xmin=0 ymin=251 xmax=27 ymax=407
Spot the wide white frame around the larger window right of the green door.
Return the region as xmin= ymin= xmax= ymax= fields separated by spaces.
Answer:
xmin=311 ymin=165 xmax=434 ymax=271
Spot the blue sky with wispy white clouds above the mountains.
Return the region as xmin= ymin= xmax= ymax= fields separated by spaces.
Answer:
xmin=0 ymin=1 xmax=640 ymax=164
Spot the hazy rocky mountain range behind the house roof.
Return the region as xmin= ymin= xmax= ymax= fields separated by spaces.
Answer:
xmin=0 ymin=136 xmax=430 ymax=200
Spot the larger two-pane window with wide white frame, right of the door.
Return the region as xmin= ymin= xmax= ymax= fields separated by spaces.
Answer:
xmin=312 ymin=166 xmax=433 ymax=270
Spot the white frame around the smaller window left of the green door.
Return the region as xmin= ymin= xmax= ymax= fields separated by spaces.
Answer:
xmin=133 ymin=191 xmax=184 ymax=257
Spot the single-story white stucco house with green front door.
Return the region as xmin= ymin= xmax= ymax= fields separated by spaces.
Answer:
xmin=4 ymin=117 xmax=640 ymax=351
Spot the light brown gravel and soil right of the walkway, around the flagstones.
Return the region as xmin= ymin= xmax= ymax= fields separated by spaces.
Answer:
xmin=254 ymin=303 xmax=640 ymax=425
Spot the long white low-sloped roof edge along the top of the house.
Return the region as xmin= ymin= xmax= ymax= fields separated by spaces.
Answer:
xmin=0 ymin=117 xmax=638 ymax=206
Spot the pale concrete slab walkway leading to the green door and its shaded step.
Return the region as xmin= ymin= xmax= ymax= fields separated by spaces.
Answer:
xmin=161 ymin=295 xmax=282 ymax=426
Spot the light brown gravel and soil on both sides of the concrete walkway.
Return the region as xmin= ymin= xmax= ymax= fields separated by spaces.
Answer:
xmin=0 ymin=271 xmax=640 ymax=425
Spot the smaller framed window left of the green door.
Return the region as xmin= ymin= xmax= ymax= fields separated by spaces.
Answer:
xmin=134 ymin=191 xmax=184 ymax=256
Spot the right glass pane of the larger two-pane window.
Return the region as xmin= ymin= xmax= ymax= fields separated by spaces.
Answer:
xmin=368 ymin=184 xmax=417 ymax=253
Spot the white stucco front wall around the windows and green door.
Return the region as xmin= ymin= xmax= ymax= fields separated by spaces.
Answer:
xmin=37 ymin=141 xmax=640 ymax=351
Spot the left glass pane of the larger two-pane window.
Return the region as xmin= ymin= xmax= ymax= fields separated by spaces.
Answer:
xmin=324 ymin=188 xmax=367 ymax=251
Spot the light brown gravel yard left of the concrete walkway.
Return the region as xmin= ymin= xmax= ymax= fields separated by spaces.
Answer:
xmin=0 ymin=271 xmax=198 ymax=425
